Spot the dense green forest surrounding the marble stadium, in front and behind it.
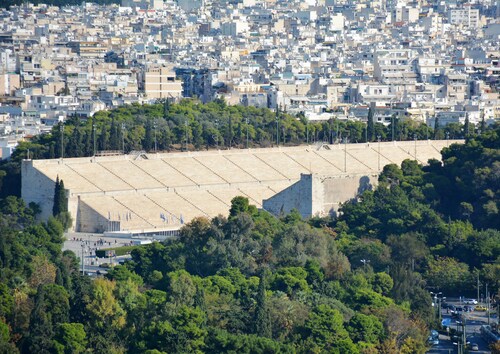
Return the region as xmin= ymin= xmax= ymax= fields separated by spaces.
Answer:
xmin=0 ymin=103 xmax=500 ymax=354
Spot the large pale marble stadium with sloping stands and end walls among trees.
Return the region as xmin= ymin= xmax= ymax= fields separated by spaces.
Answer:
xmin=22 ymin=141 xmax=463 ymax=232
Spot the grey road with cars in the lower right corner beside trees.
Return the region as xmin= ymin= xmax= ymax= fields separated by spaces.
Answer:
xmin=427 ymin=299 xmax=497 ymax=354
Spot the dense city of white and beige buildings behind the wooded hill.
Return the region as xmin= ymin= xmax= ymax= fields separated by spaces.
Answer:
xmin=0 ymin=0 xmax=500 ymax=153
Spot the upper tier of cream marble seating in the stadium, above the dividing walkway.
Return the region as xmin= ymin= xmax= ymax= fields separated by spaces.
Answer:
xmin=36 ymin=142 xmax=450 ymax=193
